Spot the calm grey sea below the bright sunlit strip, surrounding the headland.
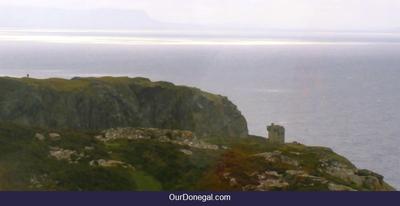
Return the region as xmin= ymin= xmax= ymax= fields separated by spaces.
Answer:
xmin=0 ymin=42 xmax=400 ymax=188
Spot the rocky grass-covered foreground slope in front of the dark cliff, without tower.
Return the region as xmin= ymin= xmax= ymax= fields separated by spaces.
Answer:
xmin=0 ymin=123 xmax=394 ymax=191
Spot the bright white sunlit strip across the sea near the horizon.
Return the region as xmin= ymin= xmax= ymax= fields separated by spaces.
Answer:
xmin=0 ymin=32 xmax=400 ymax=46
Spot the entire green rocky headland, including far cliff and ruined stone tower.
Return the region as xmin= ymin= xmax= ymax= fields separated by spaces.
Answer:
xmin=0 ymin=77 xmax=394 ymax=191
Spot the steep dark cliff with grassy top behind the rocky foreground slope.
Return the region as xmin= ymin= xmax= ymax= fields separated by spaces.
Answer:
xmin=0 ymin=77 xmax=248 ymax=137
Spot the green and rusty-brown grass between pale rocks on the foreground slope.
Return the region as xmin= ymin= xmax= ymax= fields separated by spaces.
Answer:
xmin=0 ymin=123 xmax=388 ymax=191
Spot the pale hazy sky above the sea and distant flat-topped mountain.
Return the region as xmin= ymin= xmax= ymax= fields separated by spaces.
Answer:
xmin=0 ymin=0 xmax=400 ymax=31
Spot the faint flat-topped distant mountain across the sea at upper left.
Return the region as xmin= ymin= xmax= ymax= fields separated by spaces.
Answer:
xmin=0 ymin=7 xmax=189 ymax=29
